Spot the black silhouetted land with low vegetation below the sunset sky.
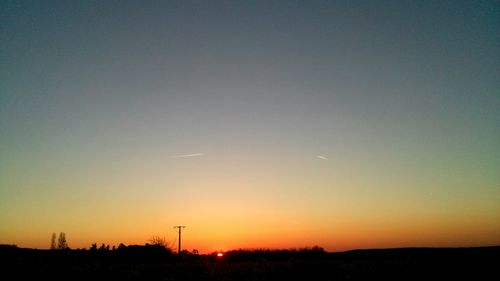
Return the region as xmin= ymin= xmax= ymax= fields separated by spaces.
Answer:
xmin=0 ymin=245 xmax=500 ymax=281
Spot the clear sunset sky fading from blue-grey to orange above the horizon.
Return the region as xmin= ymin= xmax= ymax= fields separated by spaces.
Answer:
xmin=0 ymin=0 xmax=500 ymax=252
